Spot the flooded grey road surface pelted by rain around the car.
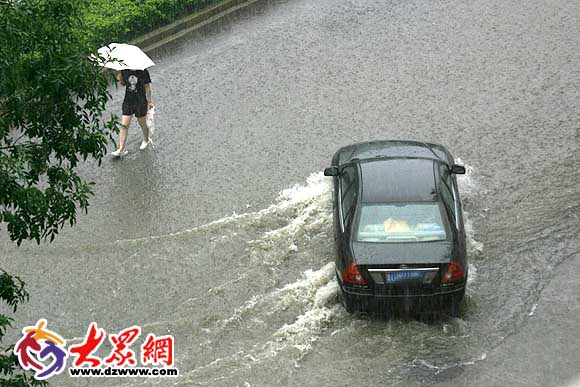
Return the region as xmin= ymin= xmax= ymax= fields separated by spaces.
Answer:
xmin=0 ymin=0 xmax=580 ymax=386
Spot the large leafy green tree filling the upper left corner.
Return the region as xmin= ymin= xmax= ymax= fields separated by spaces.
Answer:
xmin=0 ymin=0 xmax=117 ymax=244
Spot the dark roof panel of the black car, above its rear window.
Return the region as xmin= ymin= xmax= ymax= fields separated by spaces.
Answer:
xmin=358 ymin=158 xmax=437 ymax=203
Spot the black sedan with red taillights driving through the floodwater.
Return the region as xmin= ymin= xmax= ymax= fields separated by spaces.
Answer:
xmin=324 ymin=141 xmax=468 ymax=316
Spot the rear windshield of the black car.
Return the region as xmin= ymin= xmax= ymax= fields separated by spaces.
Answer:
xmin=356 ymin=203 xmax=448 ymax=243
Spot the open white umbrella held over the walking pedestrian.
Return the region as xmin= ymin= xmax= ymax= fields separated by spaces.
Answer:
xmin=99 ymin=43 xmax=155 ymax=70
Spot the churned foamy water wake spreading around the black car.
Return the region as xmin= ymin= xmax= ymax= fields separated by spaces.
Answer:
xmin=98 ymin=162 xmax=489 ymax=386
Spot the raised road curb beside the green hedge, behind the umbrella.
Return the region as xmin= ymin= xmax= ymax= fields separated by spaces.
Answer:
xmin=131 ymin=0 xmax=258 ymax=52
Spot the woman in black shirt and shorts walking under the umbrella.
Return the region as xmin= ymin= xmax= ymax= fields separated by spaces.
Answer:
xmin=111 ymin=70 xmax=153 ymax=157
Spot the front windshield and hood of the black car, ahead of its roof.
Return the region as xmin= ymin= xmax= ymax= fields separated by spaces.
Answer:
xmin=334 ymin=140 xmax=450 ymax=165
